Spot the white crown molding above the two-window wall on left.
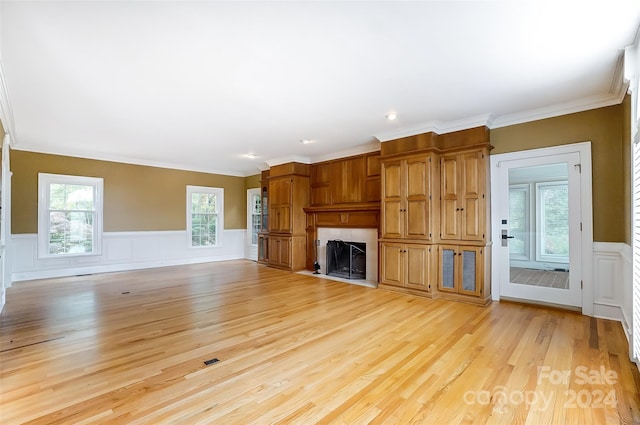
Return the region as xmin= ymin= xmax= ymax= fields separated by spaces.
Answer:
xmin=11 ymin=145 xmax=250 ymax=177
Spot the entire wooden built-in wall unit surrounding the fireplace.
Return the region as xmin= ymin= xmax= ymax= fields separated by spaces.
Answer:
xmin=258 ymin=127 xmax=491 ymax=304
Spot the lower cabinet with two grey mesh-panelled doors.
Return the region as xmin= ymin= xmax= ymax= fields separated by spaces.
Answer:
xmin=438 ymin=245 xmax=485 ymax=297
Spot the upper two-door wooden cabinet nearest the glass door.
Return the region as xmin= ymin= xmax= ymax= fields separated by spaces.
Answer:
xmin=440 ymin=149 xmax=488 ymax=241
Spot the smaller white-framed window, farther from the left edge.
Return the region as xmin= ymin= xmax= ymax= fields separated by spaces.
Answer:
xmin=187 ymin=186 xmax=224 ymax=247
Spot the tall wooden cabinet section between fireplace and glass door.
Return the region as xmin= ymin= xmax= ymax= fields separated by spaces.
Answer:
xmin=379 ymin=127 xmax=491 ymax=304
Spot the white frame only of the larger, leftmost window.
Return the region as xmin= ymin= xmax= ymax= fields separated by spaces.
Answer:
xmin=38 ymin=173 xmax=104 ymax=259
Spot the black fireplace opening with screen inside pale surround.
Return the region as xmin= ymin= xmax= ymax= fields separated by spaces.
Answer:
xmin=327 ymin=240 xmax=367 ymax=279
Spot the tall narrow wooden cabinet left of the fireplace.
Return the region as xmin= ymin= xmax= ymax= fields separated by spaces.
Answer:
xmin=268 ymin=162 xmax=309 ymax=271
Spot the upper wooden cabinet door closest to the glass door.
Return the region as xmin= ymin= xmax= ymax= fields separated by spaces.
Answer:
xmin=460 ymin=151 xmax=486 ymax=241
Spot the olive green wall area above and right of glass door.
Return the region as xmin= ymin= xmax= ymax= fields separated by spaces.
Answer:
xmin=491 ymin=105 xmax=630 ymax=242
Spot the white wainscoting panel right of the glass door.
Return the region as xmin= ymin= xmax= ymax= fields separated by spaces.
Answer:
xmin=593 ymin=242 xmax=633 ymax=337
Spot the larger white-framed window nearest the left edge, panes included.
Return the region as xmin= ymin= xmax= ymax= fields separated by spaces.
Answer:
xmin=38 ymin=173 xmax=103 ymax=258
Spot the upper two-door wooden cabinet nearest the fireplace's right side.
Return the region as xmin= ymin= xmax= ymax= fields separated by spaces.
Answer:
xmin=381 ymin=153 xmax=436 ymax=240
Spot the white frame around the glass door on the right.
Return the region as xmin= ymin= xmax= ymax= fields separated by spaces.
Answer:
xmin=490 ymin=142 xmax=593 ymax=316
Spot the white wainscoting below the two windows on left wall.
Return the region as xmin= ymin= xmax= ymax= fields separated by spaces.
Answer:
xmin=11 ymin=229 xmax=247 ymax=282
